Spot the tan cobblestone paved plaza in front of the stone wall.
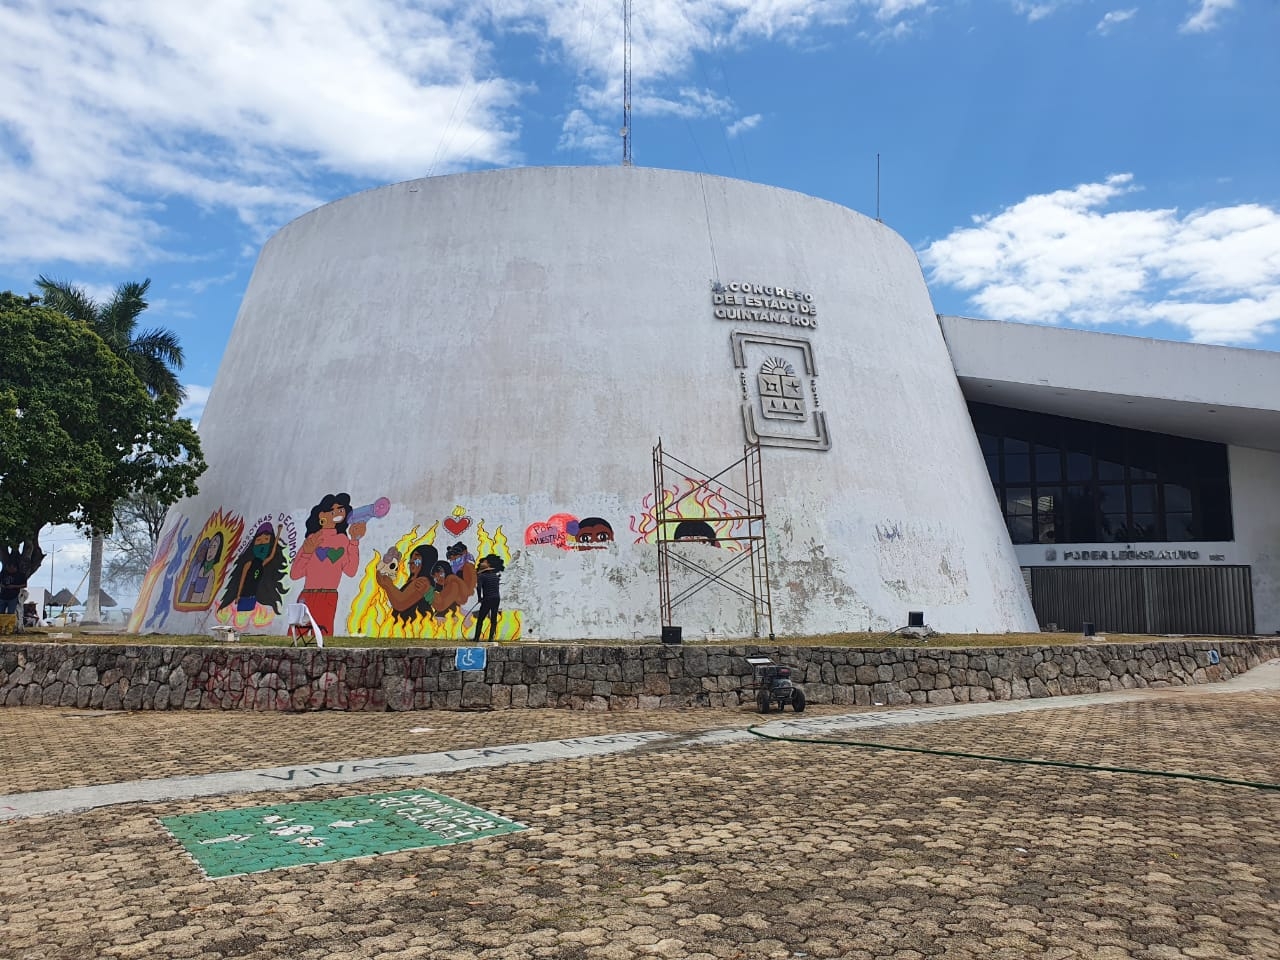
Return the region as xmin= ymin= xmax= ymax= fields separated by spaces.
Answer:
xmin=0 ymin=670 xmax=1280 ymax=960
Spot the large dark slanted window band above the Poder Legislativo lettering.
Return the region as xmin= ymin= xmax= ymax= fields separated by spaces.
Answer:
xmin=969 ymin=403 xmax=1233 ymax=543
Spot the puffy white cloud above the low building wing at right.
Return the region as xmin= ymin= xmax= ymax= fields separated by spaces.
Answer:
xmin=922 ymin=174 xmax=1280 ymax=343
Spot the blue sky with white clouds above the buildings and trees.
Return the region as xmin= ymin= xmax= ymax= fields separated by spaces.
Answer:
xmin=0 ymin=0 xmax=1280 ymax=599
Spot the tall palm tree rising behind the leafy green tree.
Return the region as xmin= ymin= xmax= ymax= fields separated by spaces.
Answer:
xmin=36 ymin=274 xmax=186 ymax=623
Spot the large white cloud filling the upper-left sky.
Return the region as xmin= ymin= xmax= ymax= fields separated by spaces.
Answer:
xmin=0 ymin=0 xmax=516 ymax=265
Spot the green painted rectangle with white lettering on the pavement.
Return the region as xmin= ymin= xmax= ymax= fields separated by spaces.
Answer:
xmin=160 ymin=790 xmax=525 ymax=878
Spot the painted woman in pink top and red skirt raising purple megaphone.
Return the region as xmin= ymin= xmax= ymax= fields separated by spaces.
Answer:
xmin=289 ymin=493 xmax=392 ymax=636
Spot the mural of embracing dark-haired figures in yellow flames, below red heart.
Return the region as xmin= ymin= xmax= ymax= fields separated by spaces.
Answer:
xmin=347 ymin=507 xmax=522 ymax=640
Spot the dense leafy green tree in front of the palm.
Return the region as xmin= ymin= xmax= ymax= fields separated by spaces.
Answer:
xmin=0 ymin=293 xmax=205 ymax=599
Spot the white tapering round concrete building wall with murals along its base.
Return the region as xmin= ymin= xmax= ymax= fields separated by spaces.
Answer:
xmin=133 ymin=166 xmax=1036 ymax=639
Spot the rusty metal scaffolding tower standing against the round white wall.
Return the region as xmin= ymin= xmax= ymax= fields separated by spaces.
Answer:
xmin=653 ymin=438 xmax=773 ymax=640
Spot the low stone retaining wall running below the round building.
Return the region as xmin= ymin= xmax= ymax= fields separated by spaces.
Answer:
xmin=0 ymin=639 xmax=1280 ymax=710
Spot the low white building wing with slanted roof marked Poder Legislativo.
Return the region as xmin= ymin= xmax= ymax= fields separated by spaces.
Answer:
xmin=941 ymin=316 xmax=1280 ymax=634
